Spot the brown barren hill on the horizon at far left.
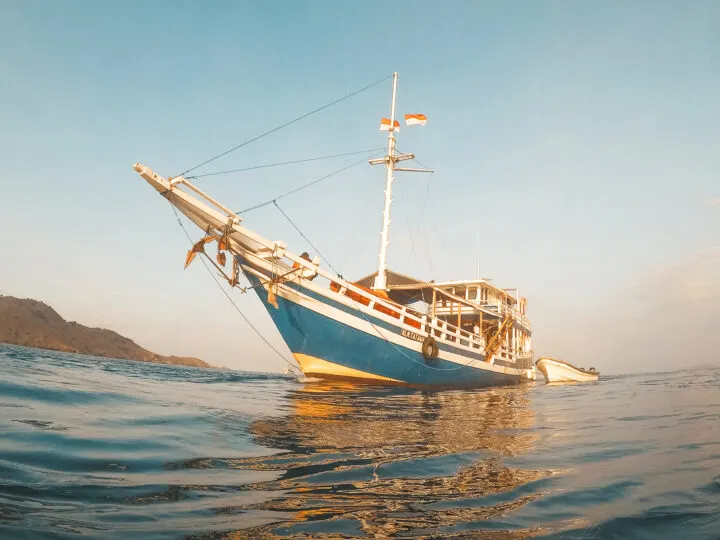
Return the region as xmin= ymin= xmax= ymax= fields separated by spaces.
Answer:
xmin=0 ymin=296 xmax=211 ymax=367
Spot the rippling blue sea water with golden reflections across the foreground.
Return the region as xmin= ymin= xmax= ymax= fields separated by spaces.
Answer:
xmin=0 ymin=346 xmax=720 ymax=539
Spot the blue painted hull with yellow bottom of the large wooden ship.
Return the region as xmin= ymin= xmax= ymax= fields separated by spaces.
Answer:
xmin=246 ymin=273 xmax=523 ymax=387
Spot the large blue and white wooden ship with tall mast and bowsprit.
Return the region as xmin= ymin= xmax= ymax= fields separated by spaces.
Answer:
xmin=134 ymin=73 xmax=535 ymax=387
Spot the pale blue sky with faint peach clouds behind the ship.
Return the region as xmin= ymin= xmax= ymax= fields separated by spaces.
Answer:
xmin=0 ymin=0 xmax=720 ymax=373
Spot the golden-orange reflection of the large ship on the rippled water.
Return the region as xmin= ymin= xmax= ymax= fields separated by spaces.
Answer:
xmin=219 ymin=383 xmax=548 ymax=538
